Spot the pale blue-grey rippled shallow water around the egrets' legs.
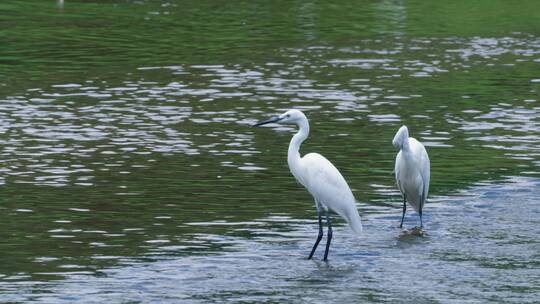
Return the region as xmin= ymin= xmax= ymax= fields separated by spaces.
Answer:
xmin=2 ymin=178 xmax=540 ymax=303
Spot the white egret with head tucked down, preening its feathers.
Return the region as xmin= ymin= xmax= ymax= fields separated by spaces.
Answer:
xmin=392 ymin=126 xmax=430 ymax=228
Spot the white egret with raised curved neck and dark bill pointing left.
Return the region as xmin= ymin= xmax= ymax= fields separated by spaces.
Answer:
xmin=253 ymin=110 xmax=362 ymax=261
